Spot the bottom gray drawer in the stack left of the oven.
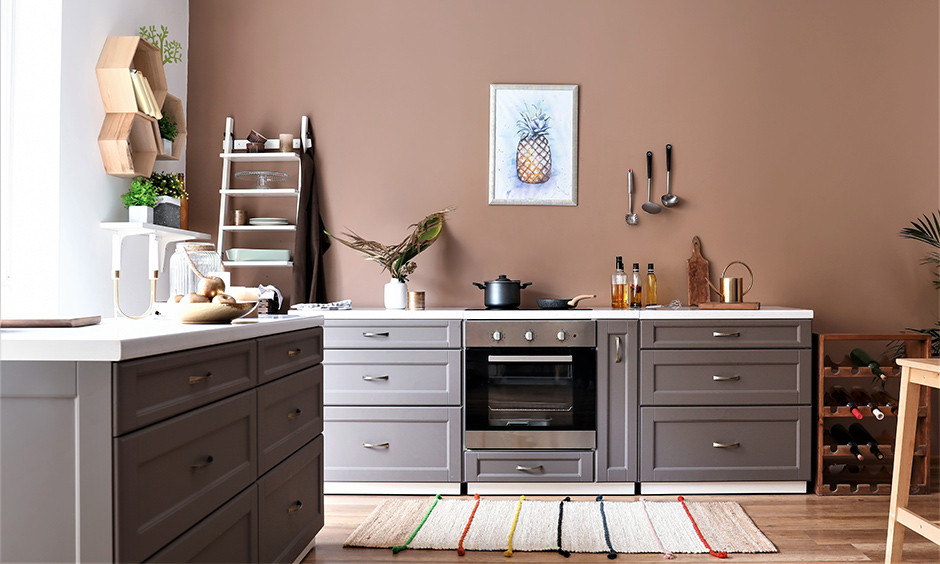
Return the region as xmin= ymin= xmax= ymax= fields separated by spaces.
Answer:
xmin=323 ymin=406 xmax=462 ymax=482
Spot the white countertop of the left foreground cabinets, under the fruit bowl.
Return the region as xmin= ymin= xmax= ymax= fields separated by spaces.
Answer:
xmin=0 ymin=315 xmax=323 ymax=362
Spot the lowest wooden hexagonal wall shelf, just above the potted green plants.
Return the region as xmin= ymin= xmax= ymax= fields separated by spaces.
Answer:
xmin=98 ymin=112 xmax=160 ymax=178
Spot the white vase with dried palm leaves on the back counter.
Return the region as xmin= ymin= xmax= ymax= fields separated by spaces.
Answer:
xmin=324 ymin=208 xmax=453 ymax=309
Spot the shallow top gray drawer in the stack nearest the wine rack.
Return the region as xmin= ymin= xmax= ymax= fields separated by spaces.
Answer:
xmin=640 ymin=319 xmax=813 ymax=349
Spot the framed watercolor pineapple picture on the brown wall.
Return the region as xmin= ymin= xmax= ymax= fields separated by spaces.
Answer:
xmin=490 ymin=84 xmax=578 ymax=206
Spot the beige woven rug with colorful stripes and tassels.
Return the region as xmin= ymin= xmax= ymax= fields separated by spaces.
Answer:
xmin=343 ymin=495 xmax=777 ymax=558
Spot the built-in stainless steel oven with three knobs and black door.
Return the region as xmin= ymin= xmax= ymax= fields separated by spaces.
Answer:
xmin=464 ymin=320 xmax=597 ymax=449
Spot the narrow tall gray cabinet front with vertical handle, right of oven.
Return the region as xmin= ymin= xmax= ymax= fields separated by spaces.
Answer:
xmin=597 ymin=320 xmax=639 ymax=482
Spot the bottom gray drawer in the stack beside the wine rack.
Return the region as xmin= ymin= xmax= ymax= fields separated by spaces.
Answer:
xmin=640 ymin=406 xmax=812 ymax=482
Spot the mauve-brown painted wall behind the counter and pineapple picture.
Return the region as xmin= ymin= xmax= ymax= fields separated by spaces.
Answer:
xmin=187 ymin=0 xmax=940 ymax=332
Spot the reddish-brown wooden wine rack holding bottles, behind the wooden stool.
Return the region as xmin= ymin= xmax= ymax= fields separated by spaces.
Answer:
xmin=813 ymin=333 xmax=930 ymax=495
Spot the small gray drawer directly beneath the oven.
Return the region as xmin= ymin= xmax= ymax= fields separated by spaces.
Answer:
xmin=464 ymin=451 xmax=594 ymax=482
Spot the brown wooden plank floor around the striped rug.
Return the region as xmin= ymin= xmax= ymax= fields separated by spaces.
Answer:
xmin=303 ymin=488 xmax=940 ymax=564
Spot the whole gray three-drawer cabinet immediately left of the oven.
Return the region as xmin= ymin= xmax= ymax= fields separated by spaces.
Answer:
xmin=323 ymin=319 xmax=462 ymax=483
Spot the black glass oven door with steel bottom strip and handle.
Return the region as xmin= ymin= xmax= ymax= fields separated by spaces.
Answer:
xmin=464 ymin=347 xmax=597 ymax=449
